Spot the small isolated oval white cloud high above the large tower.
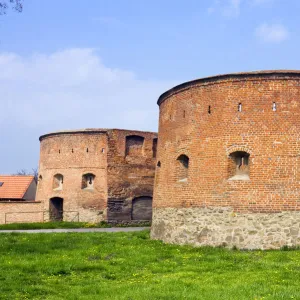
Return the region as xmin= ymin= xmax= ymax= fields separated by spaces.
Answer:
xmin=255 ymin=23 xmax=290 ymax=43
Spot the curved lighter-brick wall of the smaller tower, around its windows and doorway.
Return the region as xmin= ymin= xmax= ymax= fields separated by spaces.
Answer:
xmin=37 ymin=131 xmax=107 ymax=221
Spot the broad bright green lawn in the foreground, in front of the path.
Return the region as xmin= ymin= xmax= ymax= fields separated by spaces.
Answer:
xmin=0 ymin=231 xmax=300 ymax=300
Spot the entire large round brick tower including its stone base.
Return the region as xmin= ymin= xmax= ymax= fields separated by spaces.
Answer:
xmin=151 ymin=71 xmax=300 ymax=249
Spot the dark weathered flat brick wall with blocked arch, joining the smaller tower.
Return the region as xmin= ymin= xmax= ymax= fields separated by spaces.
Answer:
xmin=107 ymin=130 xmax=157 ymax=223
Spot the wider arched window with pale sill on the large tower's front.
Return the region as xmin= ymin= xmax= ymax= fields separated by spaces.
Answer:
xmin=229 ymin=151 xmax=250 ymax=180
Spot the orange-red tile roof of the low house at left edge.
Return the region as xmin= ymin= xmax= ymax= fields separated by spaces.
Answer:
xmin=0 ymin=175 xmax=34 ymax=199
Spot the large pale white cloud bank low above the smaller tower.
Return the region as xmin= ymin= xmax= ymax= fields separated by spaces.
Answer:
xmin=0 ymin=49 xmax=175 ymax=133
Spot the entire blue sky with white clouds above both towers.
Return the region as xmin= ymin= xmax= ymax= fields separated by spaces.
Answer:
xmin=0 ymin=0 xmax=300 ymax=174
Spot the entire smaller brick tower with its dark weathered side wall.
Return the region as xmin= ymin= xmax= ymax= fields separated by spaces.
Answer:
xmin=36 ymin=129 xmax=157 ymax=223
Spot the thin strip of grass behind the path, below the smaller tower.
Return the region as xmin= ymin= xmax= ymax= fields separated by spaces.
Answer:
xmin=0 ymin=222 xmax=150 ymax=230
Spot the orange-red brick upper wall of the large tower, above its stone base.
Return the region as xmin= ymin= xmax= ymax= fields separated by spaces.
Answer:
xmin=154 ymin=72 xmax=300 ymax=212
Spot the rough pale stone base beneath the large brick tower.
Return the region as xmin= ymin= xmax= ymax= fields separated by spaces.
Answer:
xmin=151 ymin=207 xmax=300 ymax=249
